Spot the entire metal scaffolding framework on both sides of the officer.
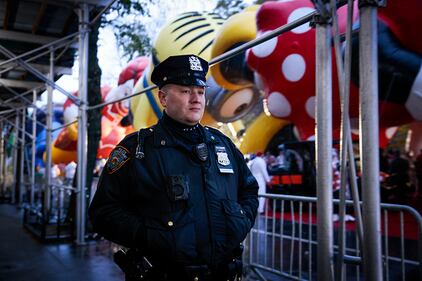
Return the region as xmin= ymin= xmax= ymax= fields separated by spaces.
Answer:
xmin=0 ymin=0 xmax=396 ymax=280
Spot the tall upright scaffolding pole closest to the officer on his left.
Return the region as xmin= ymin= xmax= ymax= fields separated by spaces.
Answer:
xmin=76 ymin=3 xmax=89 ymax=245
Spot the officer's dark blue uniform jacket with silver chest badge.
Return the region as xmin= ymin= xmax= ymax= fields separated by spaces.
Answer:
xmin=89 ymin=119 xmax=258 ymax=267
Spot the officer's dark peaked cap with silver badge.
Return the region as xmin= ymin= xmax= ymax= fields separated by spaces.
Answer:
xmin=151 ymin=55 xmax=208 ymax=89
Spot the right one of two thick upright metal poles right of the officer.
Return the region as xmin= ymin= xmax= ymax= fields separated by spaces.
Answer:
xmin=359 ymin=0 xmax=382 ymax=281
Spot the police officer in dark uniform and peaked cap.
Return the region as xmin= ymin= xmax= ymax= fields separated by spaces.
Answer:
xmin=89 ymin=55 xmax=258 ymax=281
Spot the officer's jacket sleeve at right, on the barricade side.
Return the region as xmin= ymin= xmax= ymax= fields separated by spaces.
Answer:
xmin=232 ymin=145 xmax=258 ymax=223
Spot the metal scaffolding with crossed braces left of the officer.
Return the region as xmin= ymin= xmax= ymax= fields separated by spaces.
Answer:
xmin=0 ymin=0 xmax=110 ymax=244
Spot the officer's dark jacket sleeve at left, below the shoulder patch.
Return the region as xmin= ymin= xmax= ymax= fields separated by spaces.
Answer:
xmin=88 ymin=145 xmax=145 ymax=247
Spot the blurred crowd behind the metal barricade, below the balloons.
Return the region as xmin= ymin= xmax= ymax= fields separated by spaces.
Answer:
xmin=246 ymin=145 xmax=422 ymax=205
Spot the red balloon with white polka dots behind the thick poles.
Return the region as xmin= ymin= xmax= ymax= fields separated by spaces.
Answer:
xmin=246 ymin=0 xmax=422 ymax=146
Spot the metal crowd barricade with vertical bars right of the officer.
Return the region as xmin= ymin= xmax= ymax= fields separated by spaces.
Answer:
xmin=244 ymin=194 xmax=422 ymax=281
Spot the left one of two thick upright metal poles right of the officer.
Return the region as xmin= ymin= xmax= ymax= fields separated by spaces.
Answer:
xmin=314 ymin=16 xmax=334 ymax=281
